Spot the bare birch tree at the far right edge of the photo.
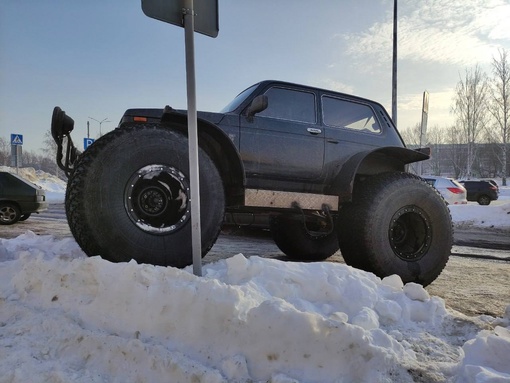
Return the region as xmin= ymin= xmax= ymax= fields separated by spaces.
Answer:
xmin=489 ymin=49 xmax=510 ymax=186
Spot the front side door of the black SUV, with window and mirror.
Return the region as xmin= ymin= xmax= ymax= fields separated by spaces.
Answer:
xmin=239 ymin=84 xmax=324 ymax=187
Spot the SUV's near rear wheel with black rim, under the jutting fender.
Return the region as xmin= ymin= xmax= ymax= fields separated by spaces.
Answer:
xmin=338 ymin=172 xmax=453 ymax=286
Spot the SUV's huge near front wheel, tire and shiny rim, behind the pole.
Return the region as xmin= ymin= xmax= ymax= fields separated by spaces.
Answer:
xmin=66 ymin=124 xmax=225 ymax=267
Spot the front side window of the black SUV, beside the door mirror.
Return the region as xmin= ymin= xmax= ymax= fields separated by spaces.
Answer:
xmin=257 ymin=87 xmax=317 ymax=124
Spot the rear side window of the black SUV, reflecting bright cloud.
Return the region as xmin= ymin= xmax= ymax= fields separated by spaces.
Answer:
xmin=322 ymin=96 xmax=381 ymax=133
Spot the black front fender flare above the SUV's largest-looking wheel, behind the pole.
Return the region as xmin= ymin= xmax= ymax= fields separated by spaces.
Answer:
xmin=161 ymin=108 xmax=246 ymax=206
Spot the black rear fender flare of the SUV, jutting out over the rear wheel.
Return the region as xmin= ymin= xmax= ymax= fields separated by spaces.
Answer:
xmin=327 ymin=146 xmax=430 ymax=204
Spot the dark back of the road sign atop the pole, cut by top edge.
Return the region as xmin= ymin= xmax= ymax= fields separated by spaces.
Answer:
xmin=142 ymin=0 xmax=219 ymax=37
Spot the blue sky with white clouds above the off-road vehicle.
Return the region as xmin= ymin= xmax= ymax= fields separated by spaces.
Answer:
xmin=0 ymin=0 xmax=510 ymax=151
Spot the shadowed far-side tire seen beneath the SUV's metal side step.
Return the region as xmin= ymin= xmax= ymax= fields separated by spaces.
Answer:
xmin=270 ymin=214 xmax=338 ymax=261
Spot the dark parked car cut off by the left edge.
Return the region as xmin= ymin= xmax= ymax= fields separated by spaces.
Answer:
xmin=0 ymin=172 xmax=48 ymax=225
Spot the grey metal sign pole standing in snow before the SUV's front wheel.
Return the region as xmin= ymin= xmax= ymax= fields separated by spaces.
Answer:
xmin=183 ymin=0 xmax=202 ymax=277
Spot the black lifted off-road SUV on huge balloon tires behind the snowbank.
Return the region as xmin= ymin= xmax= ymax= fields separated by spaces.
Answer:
xmin=52 ymin=81 xmax=452 ymax=285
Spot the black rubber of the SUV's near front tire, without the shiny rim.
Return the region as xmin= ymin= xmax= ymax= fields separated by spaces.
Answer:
xmin=65 ymin=124 xmax=225 ymax=267
